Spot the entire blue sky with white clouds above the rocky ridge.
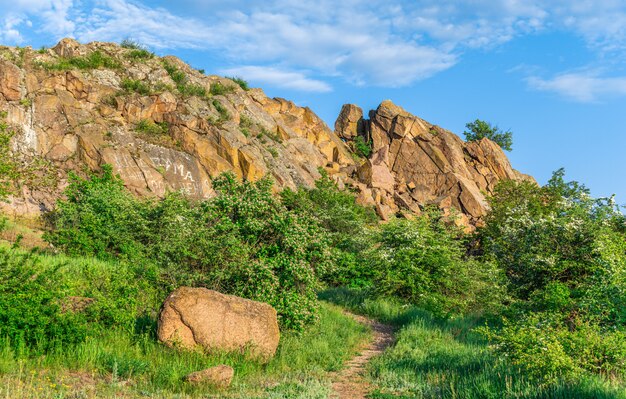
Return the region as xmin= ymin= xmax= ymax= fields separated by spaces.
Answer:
xmin=0 ymin=0 xmax=626 ymax=204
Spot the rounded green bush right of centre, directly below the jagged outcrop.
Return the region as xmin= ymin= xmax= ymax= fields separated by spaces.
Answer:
xmin=371 ymin=211 xmax=502 ymax=315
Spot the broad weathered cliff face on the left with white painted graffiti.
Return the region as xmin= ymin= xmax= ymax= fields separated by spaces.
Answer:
xmin=0 ymin=39 xmax=355 ymax=219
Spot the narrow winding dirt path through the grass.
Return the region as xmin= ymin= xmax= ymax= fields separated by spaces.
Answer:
xmin=330 ymin=313 xmax=393 ymax=399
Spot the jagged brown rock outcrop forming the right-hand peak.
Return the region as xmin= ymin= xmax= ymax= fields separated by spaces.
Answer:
xmin=336 ymin=101 xmax=533 ymax=226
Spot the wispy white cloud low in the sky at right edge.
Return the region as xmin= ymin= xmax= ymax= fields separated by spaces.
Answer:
xmin=527 ymin=72 xmax=626 ymax=103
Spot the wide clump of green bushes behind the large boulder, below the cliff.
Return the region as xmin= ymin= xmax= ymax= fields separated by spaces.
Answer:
xmin=46 ymin=167 xmax=332 ymax=330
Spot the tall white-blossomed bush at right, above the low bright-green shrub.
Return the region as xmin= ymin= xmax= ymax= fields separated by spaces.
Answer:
xmin=481 ymin=170 xmax=626 ymax=325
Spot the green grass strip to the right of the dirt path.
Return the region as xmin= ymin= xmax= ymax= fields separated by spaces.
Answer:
xmin=321 ymin=289 xmax=626 ymax=399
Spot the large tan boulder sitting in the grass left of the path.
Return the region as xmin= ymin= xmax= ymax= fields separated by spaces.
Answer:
xmin=157 ymin=287 xmax=280 ymax=359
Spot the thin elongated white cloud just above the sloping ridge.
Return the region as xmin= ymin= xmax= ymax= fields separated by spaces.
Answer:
xmin=221 ymin=66 xmax=332 ymax=93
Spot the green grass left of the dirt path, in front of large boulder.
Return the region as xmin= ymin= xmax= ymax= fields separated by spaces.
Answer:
xmin=0 ymin=304 xmax=368 ymax=398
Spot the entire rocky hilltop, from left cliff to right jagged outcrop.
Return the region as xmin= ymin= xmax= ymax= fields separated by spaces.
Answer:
xmin=0 ymin=39 xmax=531 ymax=225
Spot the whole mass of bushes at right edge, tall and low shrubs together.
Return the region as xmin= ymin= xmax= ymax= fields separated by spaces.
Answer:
xmin=480 ymin=169 xmax=626 ymax=383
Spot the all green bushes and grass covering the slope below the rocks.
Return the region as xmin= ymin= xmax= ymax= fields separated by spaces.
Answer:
xmin=0 ymin=162 xmax=626 ymax=398
